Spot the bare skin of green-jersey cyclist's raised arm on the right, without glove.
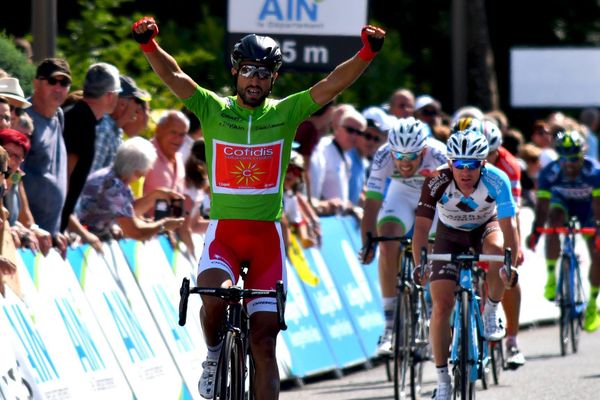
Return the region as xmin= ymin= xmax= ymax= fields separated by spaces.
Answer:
xmin=310 ymin=26 xmax=385 ymax=106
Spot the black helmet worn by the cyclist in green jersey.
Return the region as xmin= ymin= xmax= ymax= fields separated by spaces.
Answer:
xmin=231 ymin=34 xmax=282 ymax=72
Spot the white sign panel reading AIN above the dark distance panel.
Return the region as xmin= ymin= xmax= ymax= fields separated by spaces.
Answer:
xmin=227 ymin=0 xmax=368 ymax=36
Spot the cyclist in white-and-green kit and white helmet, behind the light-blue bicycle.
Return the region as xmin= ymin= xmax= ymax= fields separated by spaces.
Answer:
xmin=360 ymin=117 xmax=446 ymax=355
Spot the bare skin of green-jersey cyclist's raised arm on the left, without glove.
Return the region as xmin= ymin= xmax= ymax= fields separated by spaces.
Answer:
xmin=136 ymin=21 xmax=197 ymax=99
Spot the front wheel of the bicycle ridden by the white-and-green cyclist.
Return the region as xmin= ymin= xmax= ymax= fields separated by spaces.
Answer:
xmin=393 ymin=292 xmax=412 ymax=400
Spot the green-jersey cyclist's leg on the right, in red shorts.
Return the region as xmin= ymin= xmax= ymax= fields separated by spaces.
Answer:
xmin=244 ymin=222 xmax=286 ymax=400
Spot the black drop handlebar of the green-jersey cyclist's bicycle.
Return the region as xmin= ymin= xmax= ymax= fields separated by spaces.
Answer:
xmin=179 ymin=278 xmax=287 ymax=331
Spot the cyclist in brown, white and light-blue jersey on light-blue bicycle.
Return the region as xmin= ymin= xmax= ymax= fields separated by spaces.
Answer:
xmin=413 ymin=127 xmax=519 ymax=400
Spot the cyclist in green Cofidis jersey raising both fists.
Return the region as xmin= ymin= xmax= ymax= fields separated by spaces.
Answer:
xmin=132 ymin=17 xmax=385 ymax=400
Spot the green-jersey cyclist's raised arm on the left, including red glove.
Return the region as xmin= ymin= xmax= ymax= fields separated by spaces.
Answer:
xmin=131 ymin=17 xmax=197 ymax=99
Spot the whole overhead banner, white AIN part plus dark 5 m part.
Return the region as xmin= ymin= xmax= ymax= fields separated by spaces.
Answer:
xmin=227 ymin=0 xmax=368 ymax=71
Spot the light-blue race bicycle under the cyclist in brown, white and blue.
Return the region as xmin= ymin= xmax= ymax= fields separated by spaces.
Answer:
xmin=421 ymin=248 xmax=511 ymax=399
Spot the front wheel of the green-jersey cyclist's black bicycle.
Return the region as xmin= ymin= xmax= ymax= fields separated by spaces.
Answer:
xmin=214 ymin=331 xmax=245 ymax=400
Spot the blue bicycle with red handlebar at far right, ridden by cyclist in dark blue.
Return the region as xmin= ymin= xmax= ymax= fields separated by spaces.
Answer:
xmin=536 ymin=218 xmax=596 ymax=356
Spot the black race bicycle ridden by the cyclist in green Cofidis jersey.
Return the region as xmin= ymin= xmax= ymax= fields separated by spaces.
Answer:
xmin=179 ymin=278 xmax=287 ymax=400
